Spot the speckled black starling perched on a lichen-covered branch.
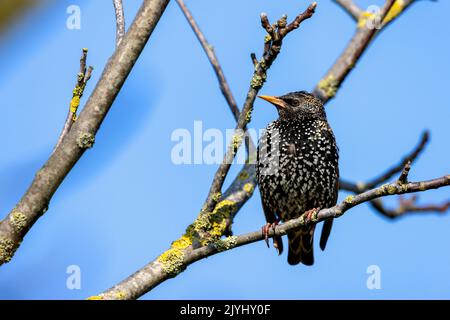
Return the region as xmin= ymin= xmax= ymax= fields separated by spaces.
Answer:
xmin=256 ymin=91 xmax=339 ymax=265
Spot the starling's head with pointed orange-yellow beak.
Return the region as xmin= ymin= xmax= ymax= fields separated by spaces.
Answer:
xmin=259 ymin=91 xmax=326 ymax=119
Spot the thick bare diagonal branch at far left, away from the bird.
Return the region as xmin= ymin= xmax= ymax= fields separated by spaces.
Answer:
xmin=0 ymin=0 xmax=169 ymax=265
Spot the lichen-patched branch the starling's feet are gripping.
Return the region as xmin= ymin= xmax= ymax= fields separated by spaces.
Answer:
xmin=90 ymin=175 xmax=450 ymax=300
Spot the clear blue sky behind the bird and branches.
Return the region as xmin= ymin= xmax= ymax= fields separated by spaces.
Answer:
xmin=0 ymin=0 xmax=450 ymax=299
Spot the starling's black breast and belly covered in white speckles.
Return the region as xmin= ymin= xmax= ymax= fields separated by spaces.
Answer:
xmin=257 ymin=120 xmax=338 ymax=219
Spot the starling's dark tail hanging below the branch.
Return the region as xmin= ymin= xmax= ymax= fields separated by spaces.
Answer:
xmin=288 ymin=226 xmax=314 ymax=266
